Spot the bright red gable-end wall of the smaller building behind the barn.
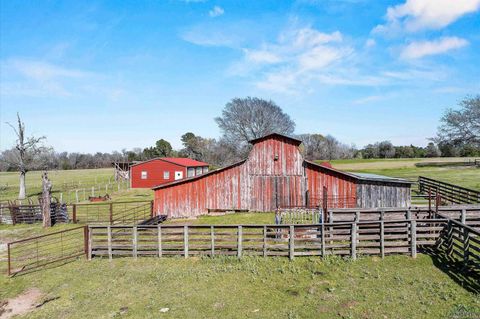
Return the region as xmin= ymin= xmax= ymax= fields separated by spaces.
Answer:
xmin=130 ymin=160 xmax=187 ymax=188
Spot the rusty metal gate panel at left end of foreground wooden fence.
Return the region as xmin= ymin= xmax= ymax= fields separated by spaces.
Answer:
xmin=7 ymin=226 xmax=88 ymax=276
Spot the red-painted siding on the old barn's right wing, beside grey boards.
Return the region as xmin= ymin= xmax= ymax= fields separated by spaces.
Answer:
xmin=305 ymin=162 xmax=357 ymax=208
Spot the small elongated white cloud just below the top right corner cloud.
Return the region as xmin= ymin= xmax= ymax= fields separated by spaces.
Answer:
xmin=400 ymin=37 xmax=468 ymax=60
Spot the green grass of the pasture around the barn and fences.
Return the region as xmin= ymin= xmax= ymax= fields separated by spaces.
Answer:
xmin=0 ymin=159 xmax=480 ymax=319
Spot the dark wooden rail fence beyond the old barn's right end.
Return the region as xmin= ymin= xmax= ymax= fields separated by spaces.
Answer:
xmin=418 ymin=176 xmax=480 ymax=204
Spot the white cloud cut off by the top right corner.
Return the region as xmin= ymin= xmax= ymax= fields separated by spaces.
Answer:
xmin=373 ymin=0 xmax=480 ymax=34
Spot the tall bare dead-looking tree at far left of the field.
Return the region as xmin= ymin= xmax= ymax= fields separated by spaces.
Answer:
xmin=7 ymin=113 xmax=45 ymax=199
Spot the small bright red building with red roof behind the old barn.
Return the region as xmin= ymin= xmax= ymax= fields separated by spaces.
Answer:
xmin=130 ymin=157 xmax=208 ymax=188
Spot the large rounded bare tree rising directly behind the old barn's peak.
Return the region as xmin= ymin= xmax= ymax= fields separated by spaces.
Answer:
xmin=215 ymin=97 xmax=295 ymax=144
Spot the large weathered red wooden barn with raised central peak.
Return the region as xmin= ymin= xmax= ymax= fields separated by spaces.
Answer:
xmin=153 ymin=134 xmax=411 ymax=217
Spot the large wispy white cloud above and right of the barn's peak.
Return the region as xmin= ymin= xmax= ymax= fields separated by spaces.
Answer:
xmin=235 ymin=27 xmax=353 ymax=93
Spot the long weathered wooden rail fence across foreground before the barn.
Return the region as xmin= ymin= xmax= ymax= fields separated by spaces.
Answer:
xmin=88 ymin=219 xmax=447 ymax=259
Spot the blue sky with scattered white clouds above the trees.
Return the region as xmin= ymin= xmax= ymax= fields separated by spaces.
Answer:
xmin=0 ymin=0 xmax=480 ymax=152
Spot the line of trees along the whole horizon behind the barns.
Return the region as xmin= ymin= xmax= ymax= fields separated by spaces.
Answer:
xmin=0 ymin=95 xmax=480 ymax=172
